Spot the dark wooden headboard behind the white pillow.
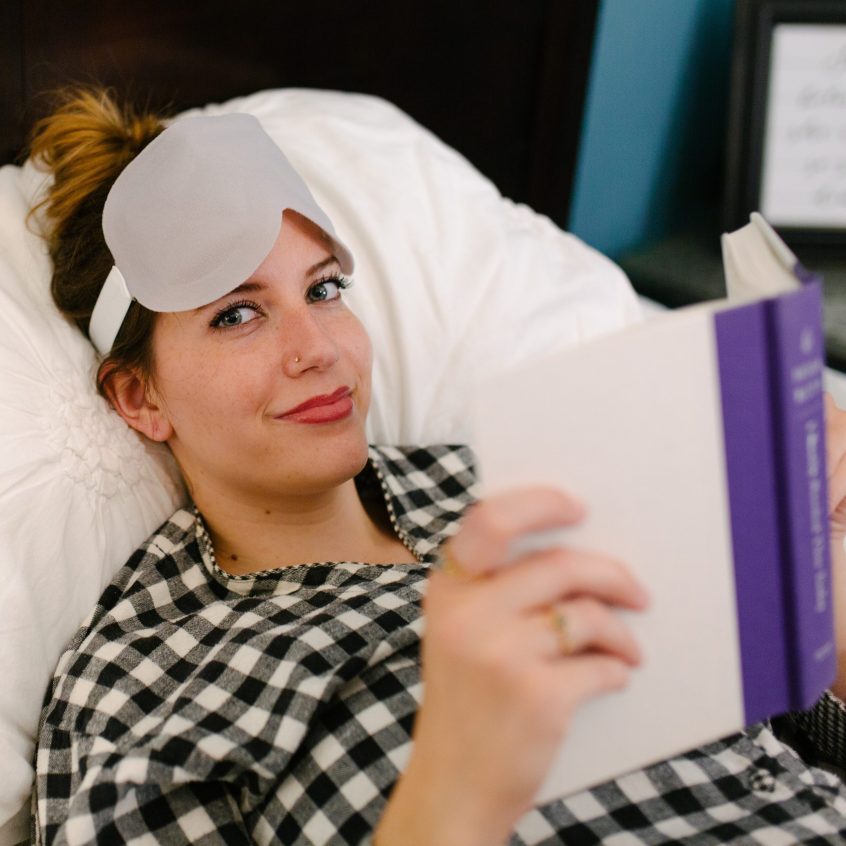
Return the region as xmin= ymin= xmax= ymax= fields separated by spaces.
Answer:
xmin=0 ymin=0 xmax=599 ymax=226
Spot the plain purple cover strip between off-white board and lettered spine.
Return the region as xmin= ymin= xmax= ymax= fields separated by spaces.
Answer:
xmin=714 ymin=302 xmax=792 ymax=725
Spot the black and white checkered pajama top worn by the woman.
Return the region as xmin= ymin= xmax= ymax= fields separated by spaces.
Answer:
xmin=33 ymin=447 xmax=846 ymax=846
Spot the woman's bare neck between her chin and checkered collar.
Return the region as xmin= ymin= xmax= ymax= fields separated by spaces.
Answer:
xmin=194 ymin=479 xmax=414 ymax=575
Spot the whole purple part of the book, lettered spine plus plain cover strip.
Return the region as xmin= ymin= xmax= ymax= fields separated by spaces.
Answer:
xmin=715 ymin=270 xmax=836 ymax=724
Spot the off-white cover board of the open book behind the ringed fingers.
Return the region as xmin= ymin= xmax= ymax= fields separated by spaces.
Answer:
xmin=473 ymin=309 xmax=743 ymax=801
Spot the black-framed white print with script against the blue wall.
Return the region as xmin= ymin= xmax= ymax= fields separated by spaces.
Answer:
xmin=725 ymin=0 xmax=846 ymax=249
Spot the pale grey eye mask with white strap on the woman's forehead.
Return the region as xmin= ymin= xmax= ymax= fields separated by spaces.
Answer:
xmin=88 ymin=114 xmax=353 ymax=355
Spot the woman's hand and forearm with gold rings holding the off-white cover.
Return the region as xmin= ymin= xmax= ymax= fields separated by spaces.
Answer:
xmin=377 ymin=488 xmax=647 ymax=846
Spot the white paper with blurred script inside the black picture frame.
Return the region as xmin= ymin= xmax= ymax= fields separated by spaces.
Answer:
xmin=761 ymin=23 xmax=846 ymax=227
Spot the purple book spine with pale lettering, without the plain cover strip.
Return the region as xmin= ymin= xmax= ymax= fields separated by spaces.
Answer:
xmin=764 ymin=280 xmax=836 ymax=709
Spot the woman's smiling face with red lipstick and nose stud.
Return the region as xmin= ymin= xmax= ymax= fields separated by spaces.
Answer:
xmin=144 ymin=211 xmax=371 ymax=501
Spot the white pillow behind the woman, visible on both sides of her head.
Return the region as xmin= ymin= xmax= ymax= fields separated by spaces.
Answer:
xmin=0 ymin=89 xmax=638 ymax=844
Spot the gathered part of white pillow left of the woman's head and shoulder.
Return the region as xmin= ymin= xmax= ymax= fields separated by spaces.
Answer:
xmin=0 ymin=166 xmax=182 ymax=842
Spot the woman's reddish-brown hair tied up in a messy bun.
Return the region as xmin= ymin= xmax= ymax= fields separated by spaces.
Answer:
xmin=29 ymin=86 xmax=164 ymax=396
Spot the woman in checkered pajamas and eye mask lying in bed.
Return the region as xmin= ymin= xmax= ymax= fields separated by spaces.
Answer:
xmin=32 ymin=92 xmax=846 ymax=846
